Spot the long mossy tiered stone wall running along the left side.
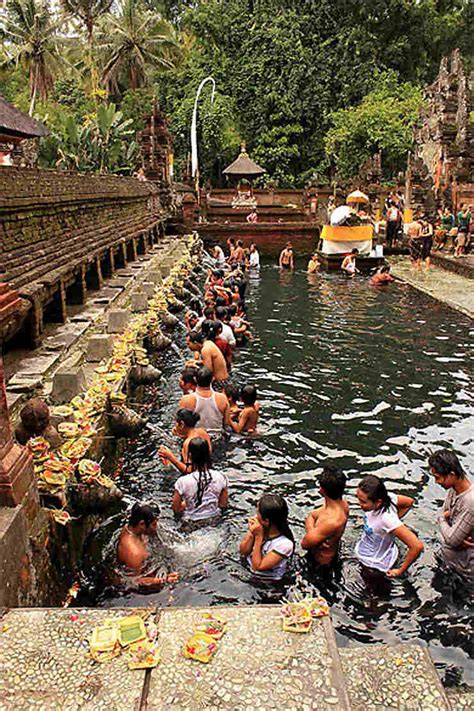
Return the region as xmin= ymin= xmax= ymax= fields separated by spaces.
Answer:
xmin=0 ymin=167 xmax=165 ymax=346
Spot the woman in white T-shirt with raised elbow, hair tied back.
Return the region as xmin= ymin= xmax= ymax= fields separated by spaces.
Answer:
xmin=355 ymin=474 xmax=423 ymax=578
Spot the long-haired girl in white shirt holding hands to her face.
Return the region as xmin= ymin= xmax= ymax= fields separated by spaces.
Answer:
xmin=240 ymin=494 xmax=295 ymax=580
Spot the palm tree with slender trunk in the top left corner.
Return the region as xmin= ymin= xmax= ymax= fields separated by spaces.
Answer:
xmin=0 ymin=0 xmax=62 ymax=116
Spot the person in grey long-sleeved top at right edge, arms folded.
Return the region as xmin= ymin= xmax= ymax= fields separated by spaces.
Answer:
xmin=428 ymin=449 xmax=474 ymax=578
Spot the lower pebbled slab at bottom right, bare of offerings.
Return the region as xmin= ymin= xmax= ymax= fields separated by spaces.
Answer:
xmin=339 ymin=644 xmax=450 ymax=711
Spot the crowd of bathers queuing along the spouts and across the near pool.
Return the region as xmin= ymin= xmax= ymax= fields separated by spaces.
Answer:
xmin=117 ymin=240 xmax=474 ymax=588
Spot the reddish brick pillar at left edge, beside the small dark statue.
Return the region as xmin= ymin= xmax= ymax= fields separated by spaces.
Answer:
xmin=0 ymin=355 xmax=39 ymax=520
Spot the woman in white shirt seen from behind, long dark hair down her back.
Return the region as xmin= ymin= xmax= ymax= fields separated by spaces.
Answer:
xmin=172 ymin=437 xmax=228 ymax=521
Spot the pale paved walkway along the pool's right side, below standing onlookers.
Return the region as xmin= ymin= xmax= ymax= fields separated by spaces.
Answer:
xmin=390 ymin=257 xmax=474 ymax=318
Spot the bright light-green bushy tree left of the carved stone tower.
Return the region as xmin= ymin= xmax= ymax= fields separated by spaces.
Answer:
xmin=325 ymin=72 xmax=423 ymax=178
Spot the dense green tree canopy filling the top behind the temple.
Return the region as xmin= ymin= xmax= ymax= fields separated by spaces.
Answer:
xmin=3 ymin=0 xmax=473 ymax=179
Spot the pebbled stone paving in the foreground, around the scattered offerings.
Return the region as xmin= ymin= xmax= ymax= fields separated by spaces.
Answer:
xmin=0 ymin=605 xmax=460 ymax=711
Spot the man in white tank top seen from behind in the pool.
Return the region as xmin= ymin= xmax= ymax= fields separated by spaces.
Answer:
xmin=179 ymin=366 xmax=230 ymax=435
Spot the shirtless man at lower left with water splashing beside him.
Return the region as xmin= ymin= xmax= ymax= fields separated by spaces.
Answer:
xmin=117 ymin=504 xmax=179 ymax=590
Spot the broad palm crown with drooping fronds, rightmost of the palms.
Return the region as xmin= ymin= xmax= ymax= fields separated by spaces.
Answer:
xmin=97 ymin=0 xmax=178 ymax=94
